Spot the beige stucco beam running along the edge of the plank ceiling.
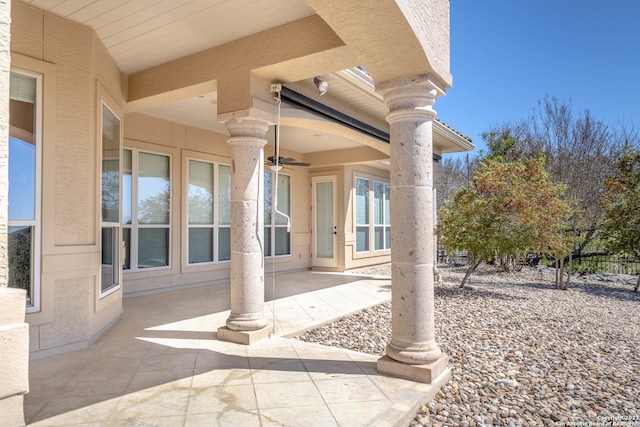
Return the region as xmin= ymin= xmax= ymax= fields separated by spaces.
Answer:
xmin=127 ymin=15 xmax=354 ymax=112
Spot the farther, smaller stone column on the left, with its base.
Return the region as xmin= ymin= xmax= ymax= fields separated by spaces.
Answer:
xmin=218 ymin=117 xmax=269 ymax=344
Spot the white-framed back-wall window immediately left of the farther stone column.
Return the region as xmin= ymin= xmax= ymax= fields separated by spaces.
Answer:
xmin=187 ymin=160 xmax=231 ymax=264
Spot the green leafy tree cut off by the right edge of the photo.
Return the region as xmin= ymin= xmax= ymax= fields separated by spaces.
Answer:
xmin=602 ymin=145 xmax=640 ymax=292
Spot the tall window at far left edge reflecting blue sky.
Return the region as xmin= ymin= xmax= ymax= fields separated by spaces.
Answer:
xmin=7 ymin=69 xmax=42 ymax=313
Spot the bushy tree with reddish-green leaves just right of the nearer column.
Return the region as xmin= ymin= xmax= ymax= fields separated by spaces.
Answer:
xmin=439 ymin=156 xmax=572 ymax=287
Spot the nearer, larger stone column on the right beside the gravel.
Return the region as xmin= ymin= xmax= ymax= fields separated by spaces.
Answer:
xmin=377 ymin=76 xmax=449 ymax=383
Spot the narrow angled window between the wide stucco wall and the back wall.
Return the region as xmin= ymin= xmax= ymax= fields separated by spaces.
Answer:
xmin=100 ymin=103 xmax=121 ymax=297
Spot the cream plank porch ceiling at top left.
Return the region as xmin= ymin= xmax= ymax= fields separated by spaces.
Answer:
xmin=22 ymin=0 xmax=313 ymax=74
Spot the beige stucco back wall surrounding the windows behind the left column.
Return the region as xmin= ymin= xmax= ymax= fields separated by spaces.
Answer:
xmin=124 ymin=113 xmax=309 ymax=295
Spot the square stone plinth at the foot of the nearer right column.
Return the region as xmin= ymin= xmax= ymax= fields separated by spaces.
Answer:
xmin=377 ymin=354 xmax=451 ymax=385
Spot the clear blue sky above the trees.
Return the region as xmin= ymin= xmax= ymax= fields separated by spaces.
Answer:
xmin=434 ymin=0 xmax=640 ymax=156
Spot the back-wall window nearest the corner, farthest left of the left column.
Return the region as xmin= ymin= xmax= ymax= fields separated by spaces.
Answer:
xmin=122 ymin=149 xmax=171 ymax=271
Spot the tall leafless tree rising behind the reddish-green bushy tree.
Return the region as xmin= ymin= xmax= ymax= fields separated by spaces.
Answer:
xmin=483 ymin=96 xmax=638 ymax=252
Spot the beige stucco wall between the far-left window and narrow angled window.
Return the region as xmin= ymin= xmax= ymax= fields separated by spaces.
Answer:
xmin=11 ymin=1 xmax=126 ymax=357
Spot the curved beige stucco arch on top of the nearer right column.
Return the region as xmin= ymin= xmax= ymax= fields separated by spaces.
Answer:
xmin=307 ymin=0 xmax=452 ymax=89
